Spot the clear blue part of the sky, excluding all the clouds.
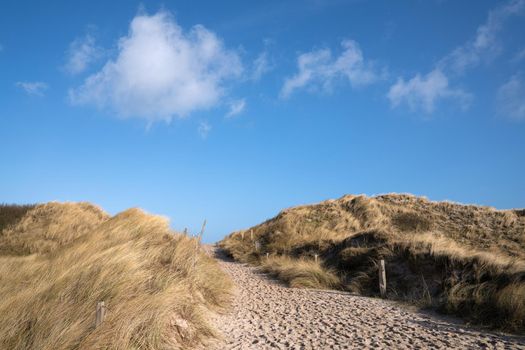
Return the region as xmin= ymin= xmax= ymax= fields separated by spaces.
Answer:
xmin=0 ymin=0 xmax=525 ymax=242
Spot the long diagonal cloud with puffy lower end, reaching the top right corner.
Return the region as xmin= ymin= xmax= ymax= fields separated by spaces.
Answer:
xmin=387 ymin=0 xmax=525 ymax=114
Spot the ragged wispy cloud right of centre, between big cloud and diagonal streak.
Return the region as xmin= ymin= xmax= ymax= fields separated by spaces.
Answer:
xmin=281 ymin=40 xmax=379 ymax=98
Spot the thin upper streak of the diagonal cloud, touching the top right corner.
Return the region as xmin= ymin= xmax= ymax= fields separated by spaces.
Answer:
xmin=438 ymin=0 xmax=525 ymax=74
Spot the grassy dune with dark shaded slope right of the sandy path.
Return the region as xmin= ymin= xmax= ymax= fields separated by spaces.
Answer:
xmin=220 ymin=194 xmax=525 ymax=332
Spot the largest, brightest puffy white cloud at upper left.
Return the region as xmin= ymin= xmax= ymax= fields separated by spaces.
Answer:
xmin=70 ymin=11 xmax=242 ymax=122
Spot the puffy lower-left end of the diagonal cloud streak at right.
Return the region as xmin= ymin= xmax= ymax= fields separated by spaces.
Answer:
xmin=387 ymin=69 xmax=471 ymax=114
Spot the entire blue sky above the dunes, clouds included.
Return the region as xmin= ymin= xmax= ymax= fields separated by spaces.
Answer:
xmin=0 ymin=0 xmax=525 ymax=241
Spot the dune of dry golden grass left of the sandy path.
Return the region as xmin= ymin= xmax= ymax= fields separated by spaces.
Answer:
xmin=0 ymin=203 xmax=231 ymax=349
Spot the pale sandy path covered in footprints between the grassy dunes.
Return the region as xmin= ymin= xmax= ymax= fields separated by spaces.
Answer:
xmin=206 ymin=247 xmax=525 ymax=349
